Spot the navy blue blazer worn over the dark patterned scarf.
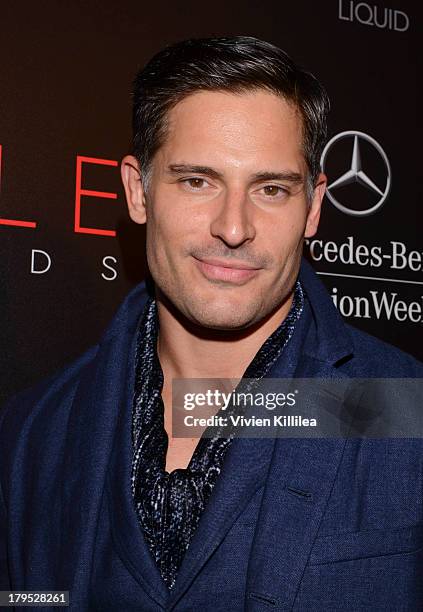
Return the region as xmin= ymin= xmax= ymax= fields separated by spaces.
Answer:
xmin=0 ymin=262 xmax=423 ymax=612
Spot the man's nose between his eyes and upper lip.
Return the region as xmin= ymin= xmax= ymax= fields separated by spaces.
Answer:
xmin=210 ymin=189 xmax=256 ymax=247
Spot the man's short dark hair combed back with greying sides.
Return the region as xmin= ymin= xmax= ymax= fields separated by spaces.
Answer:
xmin=133 ymin=36 xmax=329 ymax=199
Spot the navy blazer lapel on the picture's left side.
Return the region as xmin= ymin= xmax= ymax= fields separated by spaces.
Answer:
xmin=55 ymin=286 xmax=147 ymax=610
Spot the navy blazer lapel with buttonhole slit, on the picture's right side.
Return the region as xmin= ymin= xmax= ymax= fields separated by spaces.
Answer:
xmin=245 ymin=261 xmax=354 ymax=612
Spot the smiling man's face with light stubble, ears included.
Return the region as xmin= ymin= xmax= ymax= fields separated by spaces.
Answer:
xmin=123 ymin=90 xmax=324 ymax=330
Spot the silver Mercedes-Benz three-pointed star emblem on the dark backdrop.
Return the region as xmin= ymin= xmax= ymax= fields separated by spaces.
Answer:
xmin=320 ymin=130 xmax=391 ymax=217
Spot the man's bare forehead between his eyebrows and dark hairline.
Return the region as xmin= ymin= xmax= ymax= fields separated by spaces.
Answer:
xmin=158 ymin=90 xmax=304 ymax=169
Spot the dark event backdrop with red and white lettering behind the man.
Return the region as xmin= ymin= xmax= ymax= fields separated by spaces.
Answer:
xmin=0 ymin=0 xmax=423 ymax=401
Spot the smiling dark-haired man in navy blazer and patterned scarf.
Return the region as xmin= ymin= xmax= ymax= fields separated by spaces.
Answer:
xmin=0 ymin=37 xmax=423 ymax=612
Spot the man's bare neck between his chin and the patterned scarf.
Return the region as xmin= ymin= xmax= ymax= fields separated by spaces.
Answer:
xmin=156 ymin=291 xmax=293 ymax=387
